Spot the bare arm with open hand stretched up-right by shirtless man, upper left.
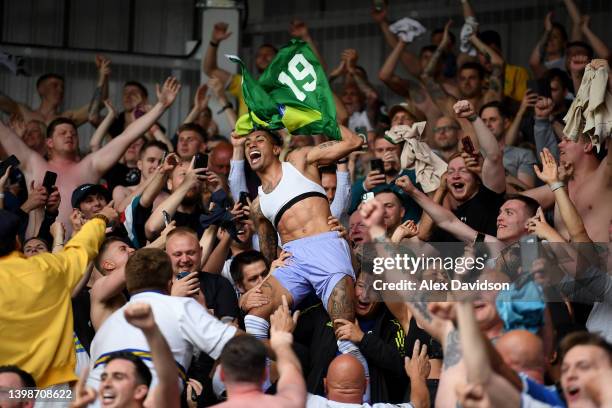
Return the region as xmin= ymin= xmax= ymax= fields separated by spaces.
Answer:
xmin=86 ymin=78 xmax=181 ymax=177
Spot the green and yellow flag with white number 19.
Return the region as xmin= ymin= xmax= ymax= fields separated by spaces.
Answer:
xmin=227 ymin=39 xmax=341 ymax=140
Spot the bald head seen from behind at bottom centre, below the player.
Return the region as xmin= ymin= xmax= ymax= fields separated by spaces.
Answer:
xmin=324 ymin=354 xmax=366 ymax=404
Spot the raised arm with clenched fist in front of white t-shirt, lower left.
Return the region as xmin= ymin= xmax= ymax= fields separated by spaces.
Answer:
xmin=124 ymin=303 xmax=181 ymax=408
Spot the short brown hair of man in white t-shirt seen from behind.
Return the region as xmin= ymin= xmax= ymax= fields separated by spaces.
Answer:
xmin=125 ymin=248 xmax=172 ymax=294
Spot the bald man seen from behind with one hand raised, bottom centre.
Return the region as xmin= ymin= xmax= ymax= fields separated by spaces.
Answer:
xmin=306 ymin=348 xmax=430 ymax=408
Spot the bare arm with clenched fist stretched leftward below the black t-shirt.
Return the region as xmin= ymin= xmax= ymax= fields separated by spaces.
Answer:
xmin=395 ymin=176 xmax=497 ymax=243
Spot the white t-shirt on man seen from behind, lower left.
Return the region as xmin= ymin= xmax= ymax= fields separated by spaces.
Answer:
xmin=87 ymin=292 xmax=236 ymax=390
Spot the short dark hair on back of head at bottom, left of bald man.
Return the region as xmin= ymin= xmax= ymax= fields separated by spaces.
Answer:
xmin=219 ymin=336 xmax=267 ymax=383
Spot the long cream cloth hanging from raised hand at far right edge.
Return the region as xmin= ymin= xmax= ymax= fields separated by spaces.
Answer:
xmin=563 ymin=65 xmax=612 ymax=151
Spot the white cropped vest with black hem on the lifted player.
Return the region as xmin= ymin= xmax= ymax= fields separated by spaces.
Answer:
xmin=258 ymin=162 xmax=327 ymax=227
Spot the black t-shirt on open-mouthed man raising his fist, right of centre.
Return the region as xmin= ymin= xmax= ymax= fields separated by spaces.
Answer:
xmin=429 ymin=184 xmax=505 ymax=242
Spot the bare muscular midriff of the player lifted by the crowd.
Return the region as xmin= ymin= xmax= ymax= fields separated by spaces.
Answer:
xmin=277 ymin=197 xmax=331 ymax=244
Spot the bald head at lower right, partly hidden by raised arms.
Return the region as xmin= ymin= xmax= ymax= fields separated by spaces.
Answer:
xmin=495 ymin=330 xmax=545 ymax=383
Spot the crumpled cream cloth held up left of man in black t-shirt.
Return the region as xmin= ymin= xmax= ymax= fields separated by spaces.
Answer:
xmin=385 ymin=122 xmax=447 ymax=193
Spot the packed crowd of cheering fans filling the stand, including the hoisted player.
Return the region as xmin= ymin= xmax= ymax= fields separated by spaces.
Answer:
xmin=0 ymin=0 xmax=612 ymax=408
